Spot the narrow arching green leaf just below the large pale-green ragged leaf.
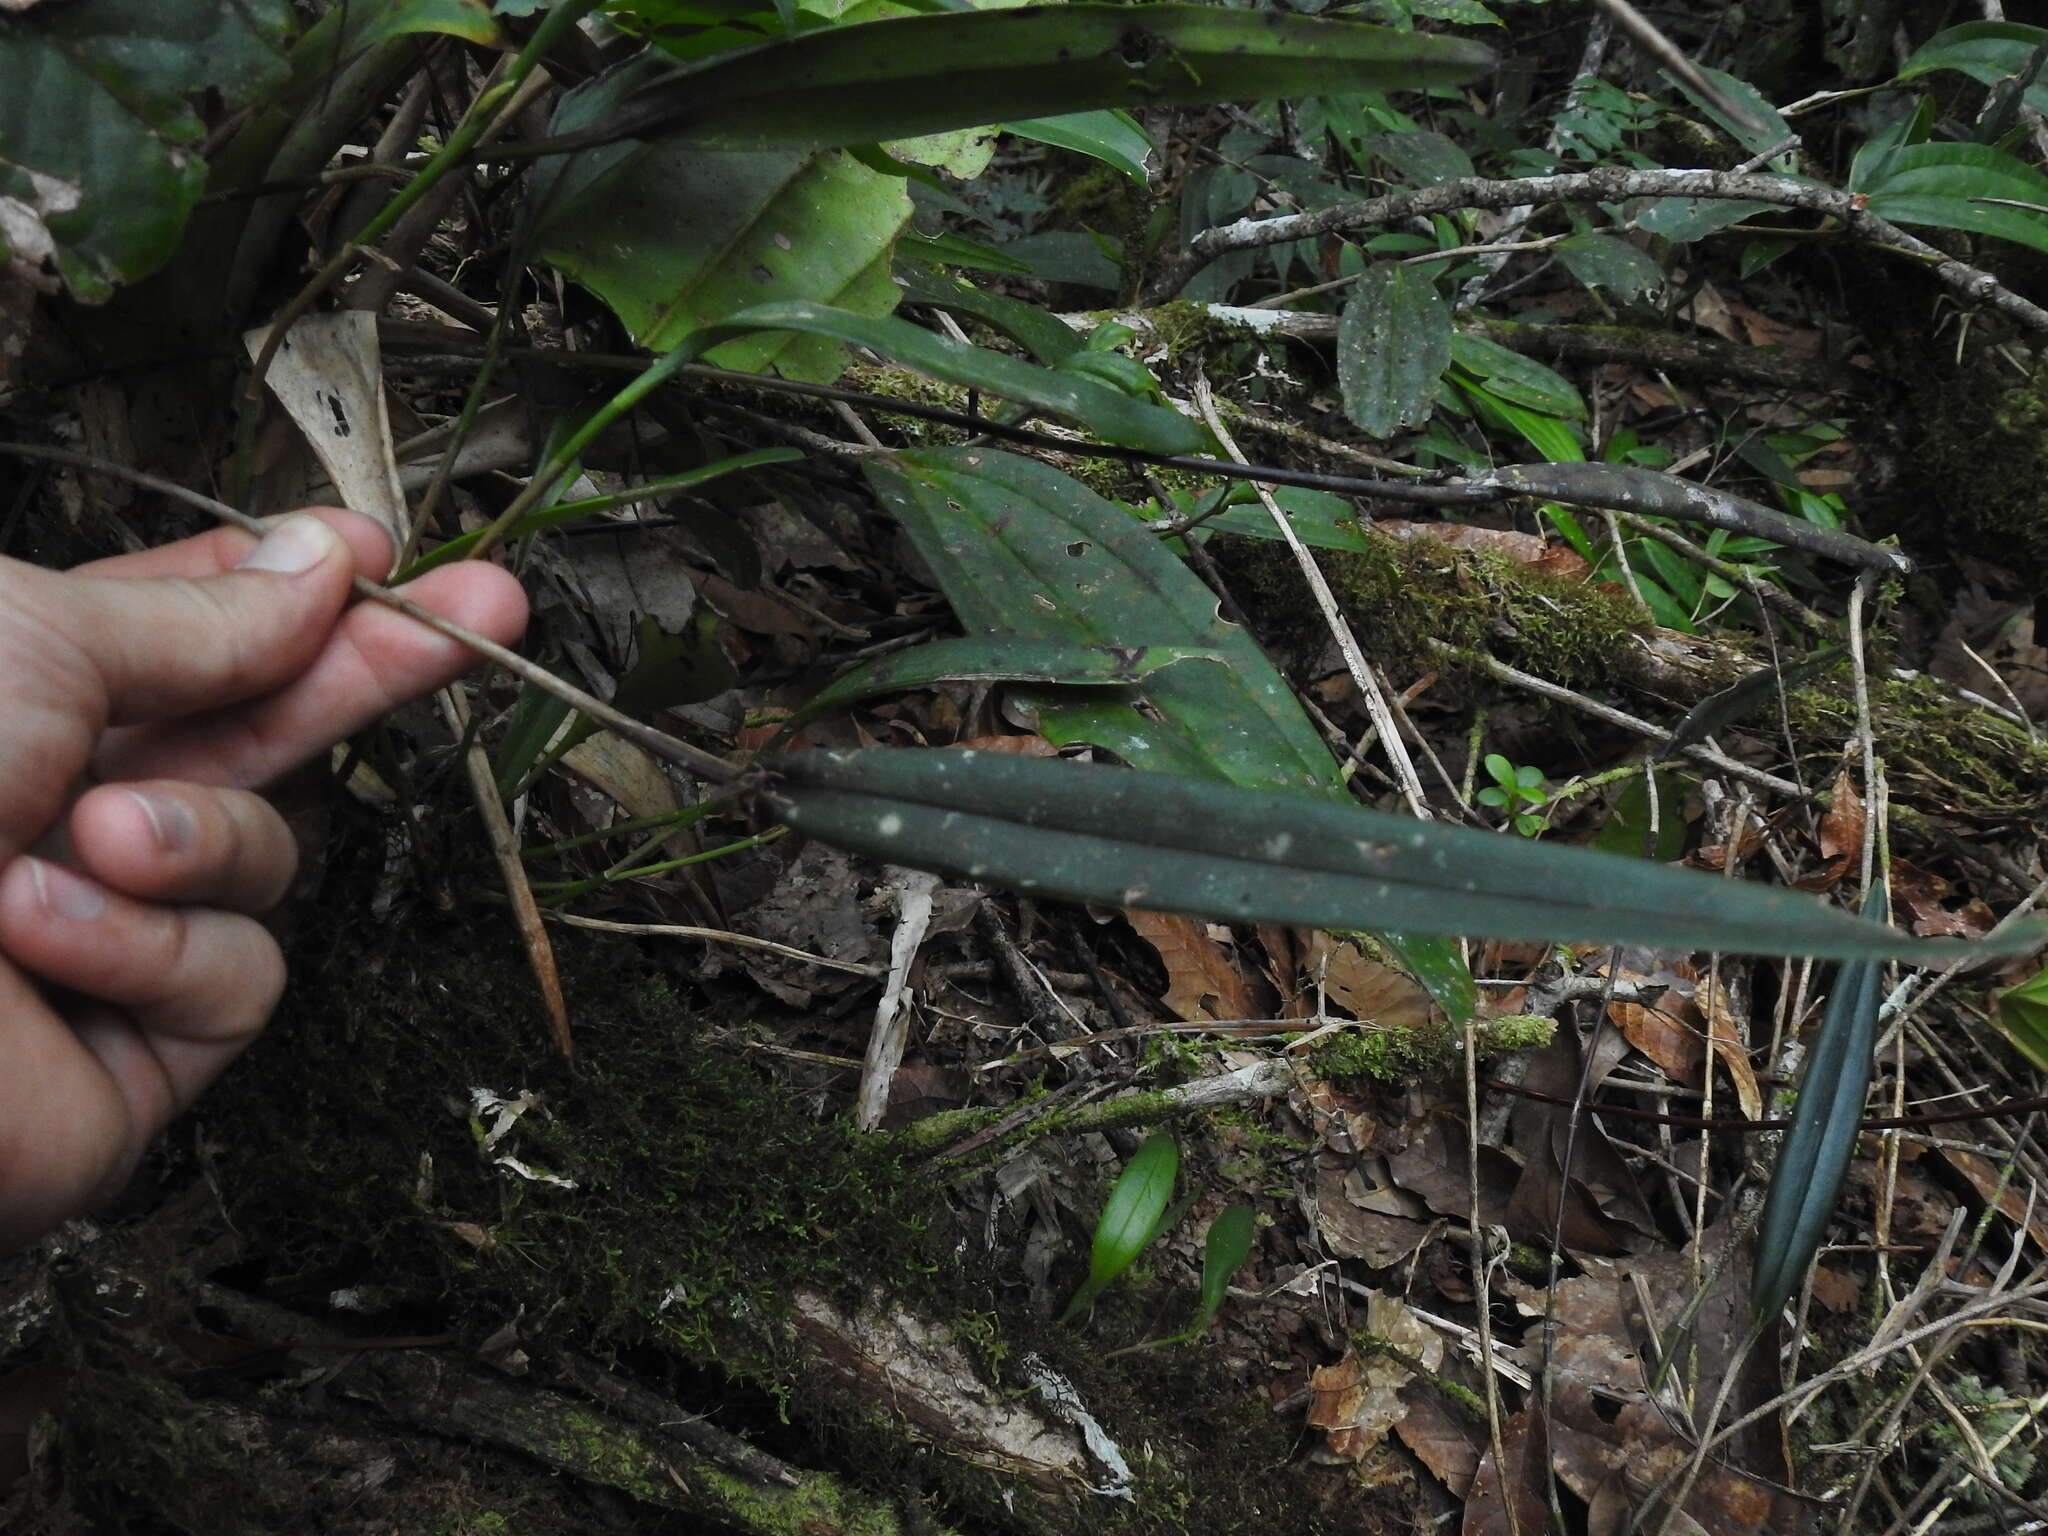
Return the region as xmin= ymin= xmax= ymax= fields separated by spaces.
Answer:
xmin=686 ymin=296 xmax=1208 ymax=453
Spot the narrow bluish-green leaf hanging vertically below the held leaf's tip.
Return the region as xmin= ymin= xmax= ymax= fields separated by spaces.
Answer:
xmin=1749 ymin=887 xmax=1888 ymax=1323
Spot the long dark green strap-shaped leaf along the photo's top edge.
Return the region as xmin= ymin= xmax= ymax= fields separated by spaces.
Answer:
xmin=602 ymin=2 xmax=1493 ymax=150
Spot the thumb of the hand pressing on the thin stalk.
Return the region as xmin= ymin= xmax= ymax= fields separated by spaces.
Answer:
xmin=45 ymin=512 xmax=354 ymax=725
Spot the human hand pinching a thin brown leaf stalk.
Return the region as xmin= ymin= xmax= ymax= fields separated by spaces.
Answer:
xmin=0 ymin=508 xmax=526 ymax=1251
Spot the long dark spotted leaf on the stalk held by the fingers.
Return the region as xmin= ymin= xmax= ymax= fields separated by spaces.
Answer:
xmin=762 ymin=753 xmax=2042 ymax=961
